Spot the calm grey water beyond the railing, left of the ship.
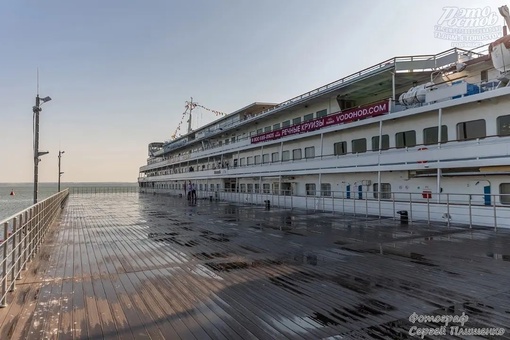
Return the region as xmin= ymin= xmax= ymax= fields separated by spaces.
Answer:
xmin=0 ymin=182 xmax=137 ymax=221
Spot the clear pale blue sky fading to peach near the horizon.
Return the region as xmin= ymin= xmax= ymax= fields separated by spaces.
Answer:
xmin=0 ymin=0 xmax=505 ymax=183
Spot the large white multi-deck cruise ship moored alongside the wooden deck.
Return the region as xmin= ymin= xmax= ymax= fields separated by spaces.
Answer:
xmin=138 ymin=29 xmax=510 ymax=228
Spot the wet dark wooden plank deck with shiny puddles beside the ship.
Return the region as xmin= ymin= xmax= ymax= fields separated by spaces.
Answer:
xmin=0 ymin=194 xmax=510 ymax=340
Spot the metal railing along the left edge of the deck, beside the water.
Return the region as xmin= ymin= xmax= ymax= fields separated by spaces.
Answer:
xmin=0 ymin=189 xmax=69 ymax=307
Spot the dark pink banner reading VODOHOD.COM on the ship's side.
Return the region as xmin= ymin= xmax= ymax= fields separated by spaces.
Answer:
xmin=251 ymin=101 xmax=389 ymax=144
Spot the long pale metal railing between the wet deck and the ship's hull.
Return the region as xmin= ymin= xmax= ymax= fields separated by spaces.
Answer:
xmin=143 ymin=187 xmax=510 ymax=230
